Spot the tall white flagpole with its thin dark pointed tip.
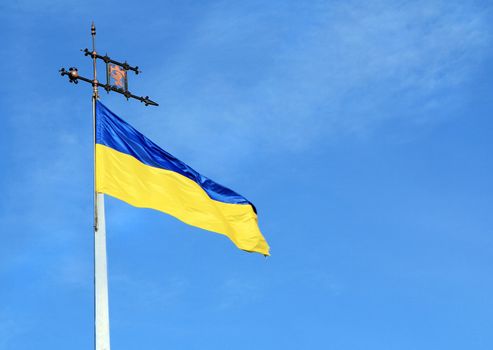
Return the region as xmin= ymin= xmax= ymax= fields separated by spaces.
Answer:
xmin=91 ymin=22 xmax=110 ymax=350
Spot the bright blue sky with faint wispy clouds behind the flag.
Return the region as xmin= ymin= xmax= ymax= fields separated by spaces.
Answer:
xmin=0 ymin=0 xmax=493 ymax=350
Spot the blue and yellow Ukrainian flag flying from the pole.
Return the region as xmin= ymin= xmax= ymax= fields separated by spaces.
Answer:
xmin=95 ymin=101 xmax=269 ymax=255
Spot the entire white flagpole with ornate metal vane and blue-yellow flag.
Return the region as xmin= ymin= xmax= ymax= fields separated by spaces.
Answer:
xmin=60 ymin=23 xmax=269 ymax=350
